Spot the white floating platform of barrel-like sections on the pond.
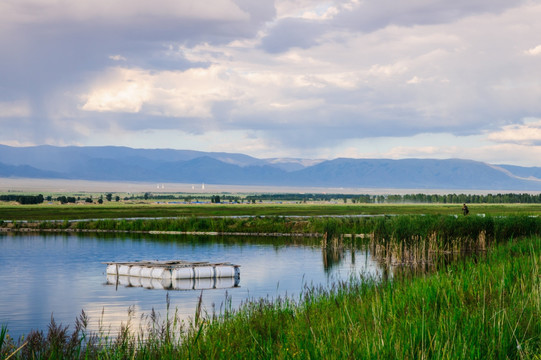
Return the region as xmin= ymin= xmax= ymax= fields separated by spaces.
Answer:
xmin=105 ymin=260 xmax=240 ymax=280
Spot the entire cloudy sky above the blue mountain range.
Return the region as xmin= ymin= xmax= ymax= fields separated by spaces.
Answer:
xmin=0 ymin=0 xmax=541 ymax=166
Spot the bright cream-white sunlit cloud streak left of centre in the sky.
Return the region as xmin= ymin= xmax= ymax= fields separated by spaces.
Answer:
xmin=81 ymin=54 xmax=357 ymax=119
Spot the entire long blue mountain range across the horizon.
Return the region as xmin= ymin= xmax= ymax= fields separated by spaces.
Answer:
xmin=0 ymin=145 xmax=541 ymax=191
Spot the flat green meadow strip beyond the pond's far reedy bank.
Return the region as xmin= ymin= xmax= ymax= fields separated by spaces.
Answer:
xmin=0 ymin=203 xmax=541 ymax=220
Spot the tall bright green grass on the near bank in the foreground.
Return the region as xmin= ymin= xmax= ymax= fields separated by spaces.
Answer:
xmin=0 ymin=237 xmax=541 ymax=359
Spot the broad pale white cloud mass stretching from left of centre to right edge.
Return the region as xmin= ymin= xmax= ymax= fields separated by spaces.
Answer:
xmin=75 ymin=0 xmax=540 ymax=152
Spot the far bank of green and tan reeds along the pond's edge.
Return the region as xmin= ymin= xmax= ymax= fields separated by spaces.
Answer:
xmin=8 ymin=215 xmax=541 ymax=266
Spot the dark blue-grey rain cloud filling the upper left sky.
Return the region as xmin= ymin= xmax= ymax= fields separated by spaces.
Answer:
xmin=0 ymin=0 xmax=274 ymax=142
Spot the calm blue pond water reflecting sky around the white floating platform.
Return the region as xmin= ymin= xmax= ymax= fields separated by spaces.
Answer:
xmin=0 ymin=234 xmax=379 ymax=338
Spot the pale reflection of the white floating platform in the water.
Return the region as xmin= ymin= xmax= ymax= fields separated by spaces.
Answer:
xmin=107 ymin=274 xmax=240 ymax=290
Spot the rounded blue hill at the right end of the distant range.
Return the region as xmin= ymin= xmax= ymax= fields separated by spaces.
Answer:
xmin=286 ymin=159 xmax=541 ymax=190
